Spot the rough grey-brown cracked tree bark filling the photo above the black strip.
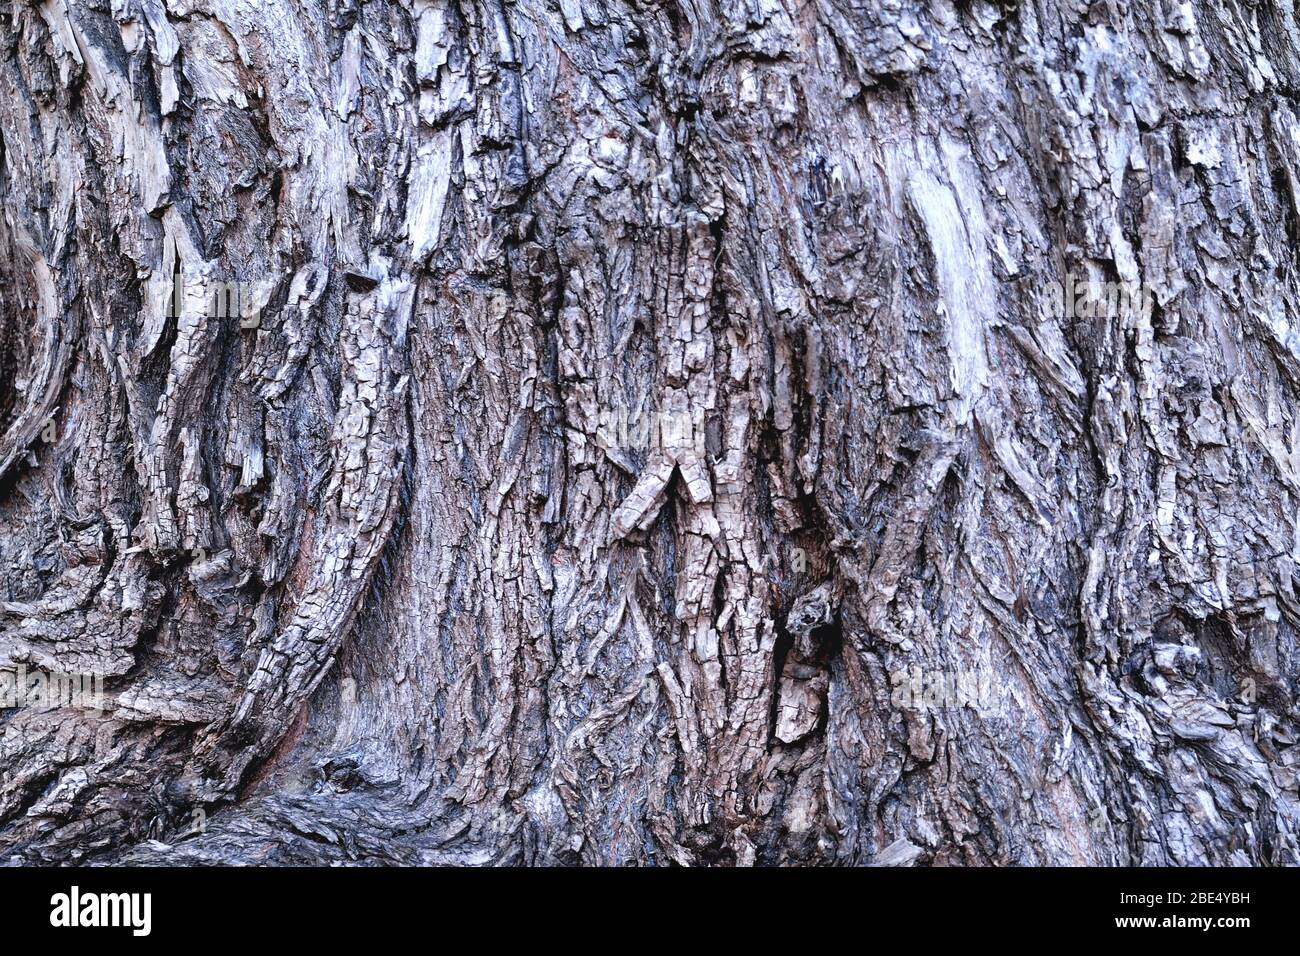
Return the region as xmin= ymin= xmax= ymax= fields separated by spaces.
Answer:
xmin=0 ymin=0 xmax=1300 ymax=865
